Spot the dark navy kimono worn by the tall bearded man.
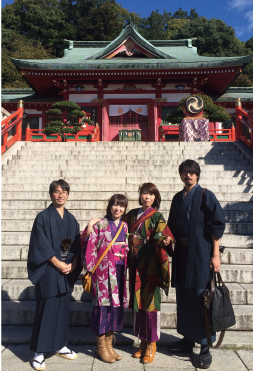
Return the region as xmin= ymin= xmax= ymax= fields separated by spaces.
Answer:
xmin=168 ymin=184 xmax=225 ymax=345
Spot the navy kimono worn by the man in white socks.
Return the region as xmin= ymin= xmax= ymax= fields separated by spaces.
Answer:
xmin=27 ymin=204 xmax=82 ymax=353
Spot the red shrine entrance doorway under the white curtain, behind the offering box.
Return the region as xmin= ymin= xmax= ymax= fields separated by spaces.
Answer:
xmin=109 ymin=109 xmax=149 ymax=142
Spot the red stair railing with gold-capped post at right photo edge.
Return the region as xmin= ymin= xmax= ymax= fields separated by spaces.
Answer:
xmin=233 ymin=99 xmax=253 ymax=151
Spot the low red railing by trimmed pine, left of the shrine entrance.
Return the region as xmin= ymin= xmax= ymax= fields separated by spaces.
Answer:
xmin=25 ymin=124 xmax=100 ymax=142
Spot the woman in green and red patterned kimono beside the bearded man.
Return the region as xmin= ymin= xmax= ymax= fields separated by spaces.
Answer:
xmin=127 ymin=183 xmax=173 ymax=363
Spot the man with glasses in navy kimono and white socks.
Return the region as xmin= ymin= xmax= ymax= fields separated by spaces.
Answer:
xmin=27 ymin=179 xmax=82 ymax=370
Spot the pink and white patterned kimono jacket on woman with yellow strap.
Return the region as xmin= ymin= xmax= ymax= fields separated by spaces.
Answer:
xmin=86 ymin=218 xmax=128 ymax=308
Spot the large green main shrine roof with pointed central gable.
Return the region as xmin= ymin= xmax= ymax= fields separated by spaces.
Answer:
xmin=12 ymin=24 xmax=251 ymax=70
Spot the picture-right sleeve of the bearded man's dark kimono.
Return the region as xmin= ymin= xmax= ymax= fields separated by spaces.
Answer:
xmin=202 ymin=190 xmax=225 ymax=238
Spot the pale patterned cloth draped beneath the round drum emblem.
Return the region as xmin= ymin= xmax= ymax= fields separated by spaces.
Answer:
xmin=178 ymin=119 xmax=210 ymax=142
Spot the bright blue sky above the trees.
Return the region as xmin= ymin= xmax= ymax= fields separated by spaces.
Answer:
xmin=2 ymin=0 xmax=253 ymax=41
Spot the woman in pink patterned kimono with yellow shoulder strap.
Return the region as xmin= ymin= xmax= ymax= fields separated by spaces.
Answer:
xmin=81 ymin=194 xmax=128 ymax=363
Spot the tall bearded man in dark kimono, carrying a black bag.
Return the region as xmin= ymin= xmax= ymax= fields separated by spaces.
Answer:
xmin=168 ymin=160 xmax=225 ymax=368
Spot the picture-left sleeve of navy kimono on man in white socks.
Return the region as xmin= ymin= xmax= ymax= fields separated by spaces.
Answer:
xmin=27 ymin=215 xmax=55 ymax=285
